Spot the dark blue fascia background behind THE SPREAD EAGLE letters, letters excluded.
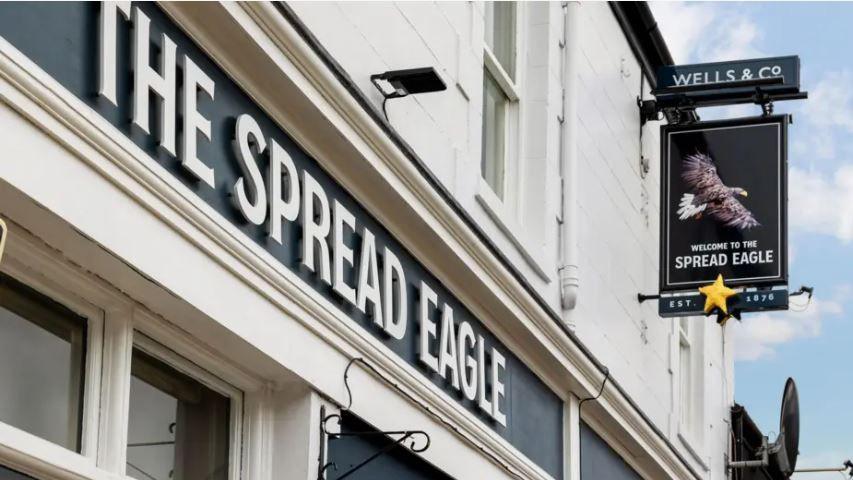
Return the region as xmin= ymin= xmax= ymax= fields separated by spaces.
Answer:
xmin=0 ymin=2 xmax=563 ymax=478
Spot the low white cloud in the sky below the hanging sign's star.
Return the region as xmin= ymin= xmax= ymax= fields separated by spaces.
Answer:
xmin=733 ymin=286 xmax=851 ymax=362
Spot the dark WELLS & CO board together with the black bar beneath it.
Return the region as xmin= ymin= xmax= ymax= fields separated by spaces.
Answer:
xmin=654 ymin=55 xmax=800 ymax=106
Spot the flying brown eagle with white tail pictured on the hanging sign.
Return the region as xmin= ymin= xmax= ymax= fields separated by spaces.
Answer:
xmin=678 ymin=152 xmax=761 ymax=230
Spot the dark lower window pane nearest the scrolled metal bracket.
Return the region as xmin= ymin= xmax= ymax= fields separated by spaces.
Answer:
xmin=127 ymin=349 xmax=231 ymax=480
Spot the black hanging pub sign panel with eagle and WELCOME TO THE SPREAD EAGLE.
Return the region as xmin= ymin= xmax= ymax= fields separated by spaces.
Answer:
xmin=660 ymin=115 xmax=788 ymax=292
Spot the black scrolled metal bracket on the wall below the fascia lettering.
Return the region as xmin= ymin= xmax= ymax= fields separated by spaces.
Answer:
xmin=317 ymin=358 xmax=431 ymax=480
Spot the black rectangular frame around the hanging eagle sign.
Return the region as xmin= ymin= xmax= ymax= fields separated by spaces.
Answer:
xmin=659 ymin=115 xmax=790 ymax=292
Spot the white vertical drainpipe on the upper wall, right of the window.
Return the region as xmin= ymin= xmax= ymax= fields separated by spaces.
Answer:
xmin=559 ymin=2 xmax=582 ymax=316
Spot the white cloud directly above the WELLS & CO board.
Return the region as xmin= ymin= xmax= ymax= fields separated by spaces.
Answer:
xmin=649 ymin=2 xmax=763 ymax=63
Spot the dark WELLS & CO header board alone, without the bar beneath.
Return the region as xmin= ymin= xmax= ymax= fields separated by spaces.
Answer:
xmin=657 ymin=55 xmax=800 ymax=92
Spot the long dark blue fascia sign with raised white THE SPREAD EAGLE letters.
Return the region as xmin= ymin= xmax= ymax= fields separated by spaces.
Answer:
xmin=0 ymin=2 xmax=564 ymax=479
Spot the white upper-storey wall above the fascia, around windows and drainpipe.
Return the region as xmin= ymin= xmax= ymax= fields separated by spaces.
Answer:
xmin=289 ymin=2 xmax=733 ymax=479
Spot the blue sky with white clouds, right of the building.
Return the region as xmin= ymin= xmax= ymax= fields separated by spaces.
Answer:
xmin=651 ymin=2 xmax=853 ymax=480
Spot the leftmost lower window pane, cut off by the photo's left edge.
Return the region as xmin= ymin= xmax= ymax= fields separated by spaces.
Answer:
xmin=0 ymin=274 xmax=86 ymax=452
